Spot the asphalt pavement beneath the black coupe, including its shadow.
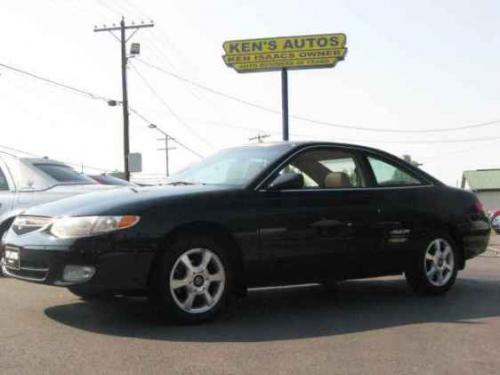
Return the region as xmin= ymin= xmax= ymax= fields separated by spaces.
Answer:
xmin=0 ymin=236 xmax=500 ymax=375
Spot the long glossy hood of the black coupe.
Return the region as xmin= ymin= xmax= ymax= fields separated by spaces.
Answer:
xmin=24 ymin=185 xmax=237 ymax=217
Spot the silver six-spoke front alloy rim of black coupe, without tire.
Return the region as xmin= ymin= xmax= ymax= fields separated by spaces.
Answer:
xmin=170 ymin=248 xmax=226 ymax=314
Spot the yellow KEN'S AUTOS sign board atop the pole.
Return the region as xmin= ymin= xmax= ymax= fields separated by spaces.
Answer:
xmin=223 ymin=34 xmax=347 ymax=73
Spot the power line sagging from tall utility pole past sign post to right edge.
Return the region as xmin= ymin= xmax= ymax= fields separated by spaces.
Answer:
xmin=136 ymin=58 xmax=500 ymax=133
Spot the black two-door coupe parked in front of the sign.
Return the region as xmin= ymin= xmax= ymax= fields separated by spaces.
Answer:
xmin=2 ymin=143 xmax=490 ymax=322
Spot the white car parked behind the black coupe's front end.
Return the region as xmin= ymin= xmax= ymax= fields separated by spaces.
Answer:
xmin=0 ymin=154 xmax=114 ymax=274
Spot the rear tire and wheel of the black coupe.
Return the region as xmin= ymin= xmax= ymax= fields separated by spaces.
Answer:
xmin=405 ymin=236 xmax=459 ymax=295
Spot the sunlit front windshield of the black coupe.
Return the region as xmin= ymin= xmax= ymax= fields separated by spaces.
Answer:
xmin=170 ymin=146 xmax=288 ymax=186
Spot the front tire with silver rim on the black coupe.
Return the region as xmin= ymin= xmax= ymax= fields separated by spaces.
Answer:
xmin=153 ymin=236 xmax=232 ymax=324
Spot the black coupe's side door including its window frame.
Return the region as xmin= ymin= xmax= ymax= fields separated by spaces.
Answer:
xmin=258 ymin=146 xmax=377 ymax=282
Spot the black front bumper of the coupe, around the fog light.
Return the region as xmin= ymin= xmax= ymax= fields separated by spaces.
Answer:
xmin=1 ymin=243 xmax=153 ymax=292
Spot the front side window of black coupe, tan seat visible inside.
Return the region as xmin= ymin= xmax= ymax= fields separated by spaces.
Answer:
xmin=279 ymin=149 xmax=365 ymax=189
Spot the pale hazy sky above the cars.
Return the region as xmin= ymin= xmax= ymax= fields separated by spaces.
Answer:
xmin=0 ymin=0 xmax=500 ymax=185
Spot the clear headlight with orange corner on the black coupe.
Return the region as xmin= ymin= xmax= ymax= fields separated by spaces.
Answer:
xmin=50 ymin=215 xmax=139 ymax=238
